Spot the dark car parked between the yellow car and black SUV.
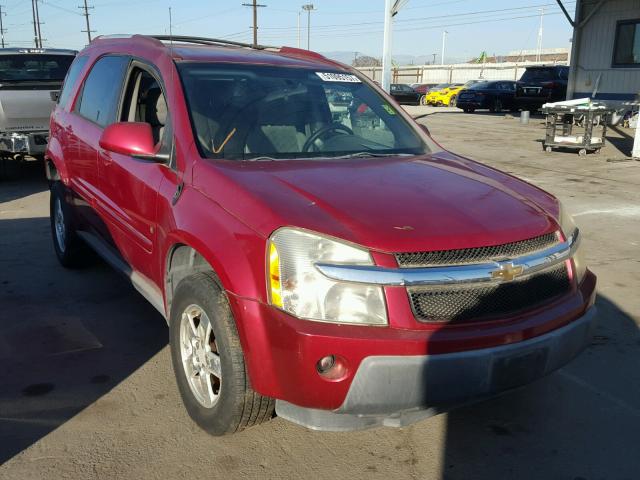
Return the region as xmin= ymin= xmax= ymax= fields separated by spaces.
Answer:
xmin=457 ymin=80 xmax=516 ymax=113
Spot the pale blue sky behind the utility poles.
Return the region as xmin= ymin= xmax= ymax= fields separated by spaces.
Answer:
xmin=1 ymin=0 xmax=575 ymax=61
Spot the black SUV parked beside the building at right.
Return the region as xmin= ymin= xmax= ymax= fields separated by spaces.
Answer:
xmin=515 ymin=65 xmax=569 ymax=111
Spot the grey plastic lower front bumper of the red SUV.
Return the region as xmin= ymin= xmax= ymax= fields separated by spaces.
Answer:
xmin=276 ymin=307 xmax=596 ymax=431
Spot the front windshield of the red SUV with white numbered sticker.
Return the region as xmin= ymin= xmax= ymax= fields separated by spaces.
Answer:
xmin=178 ymin=63 xmax=429 ymax=160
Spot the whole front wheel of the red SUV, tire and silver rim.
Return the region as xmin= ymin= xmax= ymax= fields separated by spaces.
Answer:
xmin=169 ymin=273 xmax=275 ymax=436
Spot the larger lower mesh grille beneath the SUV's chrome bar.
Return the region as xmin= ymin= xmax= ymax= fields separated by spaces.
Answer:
xmin=407 ymin=263 xmax=571 ymax=324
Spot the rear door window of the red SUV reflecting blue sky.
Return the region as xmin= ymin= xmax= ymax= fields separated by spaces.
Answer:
xmin=76 ymin=56 xmax=129 ymax=127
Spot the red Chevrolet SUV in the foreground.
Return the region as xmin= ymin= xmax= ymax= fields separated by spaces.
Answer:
xmin=46 ymin=35 xmax=596 ymax=435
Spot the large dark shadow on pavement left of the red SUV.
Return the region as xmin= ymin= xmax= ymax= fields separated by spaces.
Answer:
xmin=0 ymin=218 xmax=168 ymax=465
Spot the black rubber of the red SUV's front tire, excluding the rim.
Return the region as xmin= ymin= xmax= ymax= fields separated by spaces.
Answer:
xmin=169 ymin=273 xmax=275 ymax=436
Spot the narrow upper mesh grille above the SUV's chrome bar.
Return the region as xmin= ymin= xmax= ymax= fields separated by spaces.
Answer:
xmin=396 ymin=232 xmax=558 ymax=267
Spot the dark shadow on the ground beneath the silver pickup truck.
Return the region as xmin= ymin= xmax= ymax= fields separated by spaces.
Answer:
xmin=0 ymin=159 xmax=49 ymax=204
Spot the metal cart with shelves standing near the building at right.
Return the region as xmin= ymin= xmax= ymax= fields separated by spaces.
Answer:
xmin=542 ymin=98 xmax=614 ymax=156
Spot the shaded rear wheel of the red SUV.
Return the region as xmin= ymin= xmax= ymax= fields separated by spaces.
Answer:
xmin=49 ymin=182 xmax=91 ymax=268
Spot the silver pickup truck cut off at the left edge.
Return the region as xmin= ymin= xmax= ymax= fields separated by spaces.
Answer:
xmin=0 ymin=48 xmax=77 ymax=158
